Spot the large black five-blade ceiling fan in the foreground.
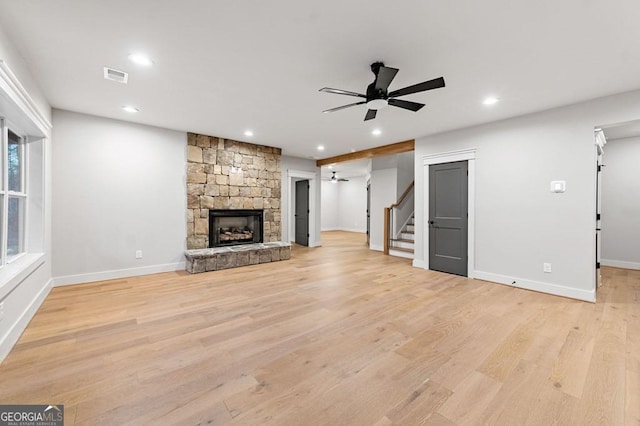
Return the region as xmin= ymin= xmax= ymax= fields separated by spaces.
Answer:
xmin=320 ymin=62 xmax=444 ymax=121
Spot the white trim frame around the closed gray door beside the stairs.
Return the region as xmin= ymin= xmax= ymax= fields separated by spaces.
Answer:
xmin=422 ymin=149 xmax=476 ymax=278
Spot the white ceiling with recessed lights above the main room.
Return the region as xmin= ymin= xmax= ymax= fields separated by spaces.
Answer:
xmin=0 ymin=0 xmax=640 ymax=158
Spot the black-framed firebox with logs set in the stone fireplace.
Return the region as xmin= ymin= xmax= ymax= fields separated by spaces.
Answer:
xmin=209 ymin=210 xmax=264 ymax=247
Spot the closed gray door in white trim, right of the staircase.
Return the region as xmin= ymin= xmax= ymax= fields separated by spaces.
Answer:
xmin=429 ymin=161 xmax=468 ymax=276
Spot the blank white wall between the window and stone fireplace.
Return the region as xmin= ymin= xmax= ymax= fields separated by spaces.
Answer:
xmin=53 ymin=110 xmax=187 ymax=285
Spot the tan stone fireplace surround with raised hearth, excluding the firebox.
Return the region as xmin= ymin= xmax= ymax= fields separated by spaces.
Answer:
xmin=185 ymin=133 xmax=291 ymax=273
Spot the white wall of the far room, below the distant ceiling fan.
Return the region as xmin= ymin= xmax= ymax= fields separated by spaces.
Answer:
xmin=322 ymin=176 xmax=367 ymax=233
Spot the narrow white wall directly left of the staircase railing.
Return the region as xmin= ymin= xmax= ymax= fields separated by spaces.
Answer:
xmin=369 ymin=165 xmax=398 ymax=251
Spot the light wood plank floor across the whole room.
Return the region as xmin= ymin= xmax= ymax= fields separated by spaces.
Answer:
xmin=0 ymin=232 xmax=640 ymax=425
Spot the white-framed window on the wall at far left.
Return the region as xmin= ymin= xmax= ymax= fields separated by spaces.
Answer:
xmin=0 ymin=119 xmax=27 ymax=265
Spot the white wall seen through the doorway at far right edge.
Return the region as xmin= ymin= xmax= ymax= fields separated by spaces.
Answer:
xmin=601 ymin=137 xmax=640 ymax=269
